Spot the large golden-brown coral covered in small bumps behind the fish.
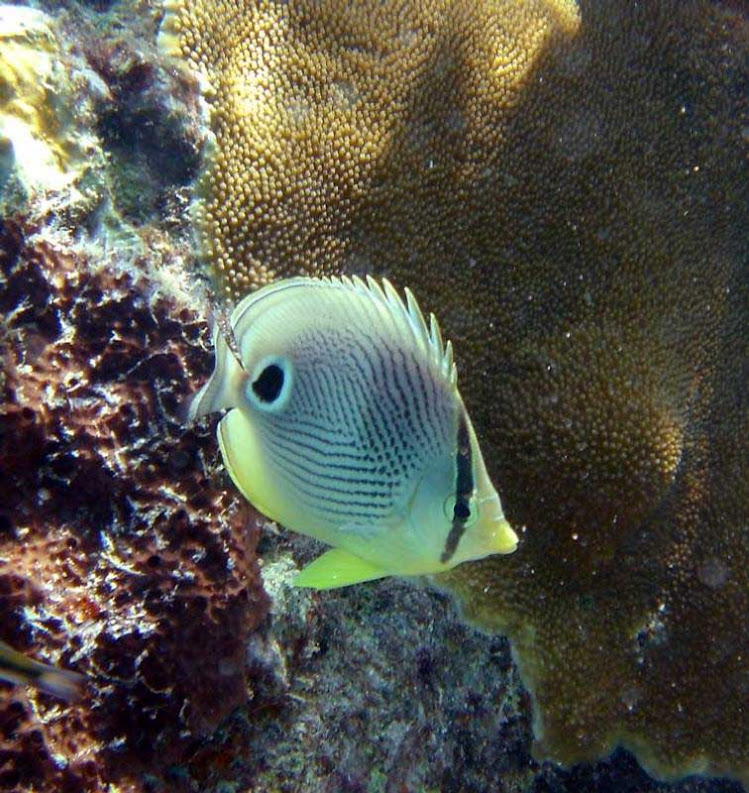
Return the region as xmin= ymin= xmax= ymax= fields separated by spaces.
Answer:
xmin=162 ymin=0 xmax=749 ymax=777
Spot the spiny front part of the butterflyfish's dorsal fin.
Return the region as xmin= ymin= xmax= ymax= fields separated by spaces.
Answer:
xmin=344 ymin=275 xmax=458 ymax=387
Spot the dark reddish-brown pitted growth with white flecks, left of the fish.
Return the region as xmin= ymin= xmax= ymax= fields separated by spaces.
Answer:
xmin=0 ymin=220 xmax=266 ymax=791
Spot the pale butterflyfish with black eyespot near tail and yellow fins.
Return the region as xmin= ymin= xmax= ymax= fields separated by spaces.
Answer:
xmin=187 ymin=276 xmax=518 ymax=589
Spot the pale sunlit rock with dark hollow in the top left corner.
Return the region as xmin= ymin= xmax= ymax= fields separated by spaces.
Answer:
xmin=0 ymin=3 xmax=205 ymax=238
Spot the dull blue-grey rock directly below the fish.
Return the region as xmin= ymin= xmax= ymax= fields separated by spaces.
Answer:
xmin=148 ymin=540 xmax=741 ymax=793
